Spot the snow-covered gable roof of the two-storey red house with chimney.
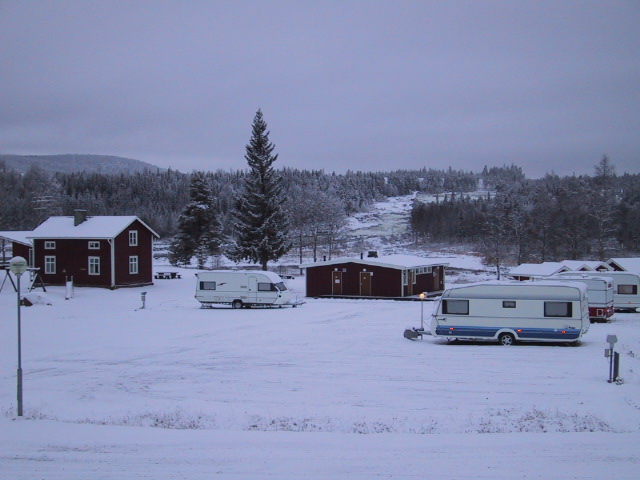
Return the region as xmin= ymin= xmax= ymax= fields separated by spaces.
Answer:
xmin=28 ymin=215 xmax=160 ymax=239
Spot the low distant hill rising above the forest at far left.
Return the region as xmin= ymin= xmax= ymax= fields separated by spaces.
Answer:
xmin=0 ymin=154 xmax=164 ymax=174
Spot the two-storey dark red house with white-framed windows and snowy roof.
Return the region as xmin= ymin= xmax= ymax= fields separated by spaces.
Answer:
xmin=29 ymin=210 xmax=159 ymax=288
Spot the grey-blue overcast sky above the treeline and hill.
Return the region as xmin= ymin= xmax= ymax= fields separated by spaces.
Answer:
xmin=0 ymin=0 xmax=640 ymax=177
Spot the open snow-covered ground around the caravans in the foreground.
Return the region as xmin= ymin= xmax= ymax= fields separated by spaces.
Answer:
xmin=0 ymin=262 xmax=640 ymax=480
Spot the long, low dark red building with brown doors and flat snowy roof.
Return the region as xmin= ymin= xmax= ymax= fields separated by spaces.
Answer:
xmin=300 ymin=255 xmax=447 ymax=298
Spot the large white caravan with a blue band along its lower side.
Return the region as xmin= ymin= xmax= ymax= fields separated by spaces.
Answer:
xmin=431 ymin=281 xmax=590 ymax=345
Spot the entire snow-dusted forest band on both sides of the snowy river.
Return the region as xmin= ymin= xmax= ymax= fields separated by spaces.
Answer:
xmin=0 ymin=157 xmax=640 ymax=264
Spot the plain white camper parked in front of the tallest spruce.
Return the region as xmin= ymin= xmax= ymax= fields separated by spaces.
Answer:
xmin=196 ymin=270 xmax=302 ymax=308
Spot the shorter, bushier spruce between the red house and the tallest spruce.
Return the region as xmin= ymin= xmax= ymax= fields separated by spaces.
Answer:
xmin=169 ymin=172 xmax=222 ymax=268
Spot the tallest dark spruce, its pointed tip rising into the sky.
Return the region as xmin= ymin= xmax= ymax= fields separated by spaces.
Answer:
xmin=227 ymin=110 xmax=290 ymax=270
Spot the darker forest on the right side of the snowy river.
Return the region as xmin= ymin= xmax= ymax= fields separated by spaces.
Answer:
xmin=411 ymin=157 xmax=640 ymax=266
